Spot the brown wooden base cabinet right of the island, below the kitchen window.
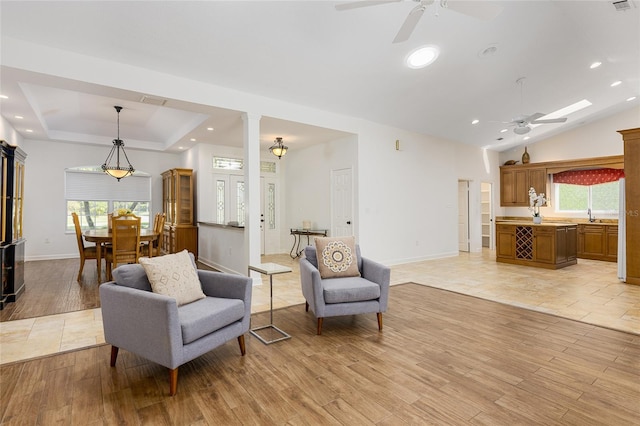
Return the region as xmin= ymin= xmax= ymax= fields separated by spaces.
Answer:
xmin=578 ymin=223 xmax=618 ymax=262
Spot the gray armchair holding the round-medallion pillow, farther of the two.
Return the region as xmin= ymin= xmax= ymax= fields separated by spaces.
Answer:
xmin=300 ymin=245 xmax=391 ymax=335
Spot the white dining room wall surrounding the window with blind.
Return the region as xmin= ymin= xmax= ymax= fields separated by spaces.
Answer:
xmin=22 ymin=139 xmax=181 ymax=261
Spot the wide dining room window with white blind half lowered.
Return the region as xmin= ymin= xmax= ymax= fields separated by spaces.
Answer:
xmin=64 ymin=166 xmax=151 ymax=232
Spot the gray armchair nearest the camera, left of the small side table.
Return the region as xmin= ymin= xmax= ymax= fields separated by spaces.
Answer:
xmin=100 ymin=258 xmax=252 ymax=396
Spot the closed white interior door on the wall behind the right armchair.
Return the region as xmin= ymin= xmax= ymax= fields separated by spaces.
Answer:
xmin=331 ymin=168 xmax=353 ymax=237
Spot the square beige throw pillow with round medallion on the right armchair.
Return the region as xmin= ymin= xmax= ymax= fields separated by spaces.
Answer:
xmin=315 ymin=237 xmax=360 ymax=278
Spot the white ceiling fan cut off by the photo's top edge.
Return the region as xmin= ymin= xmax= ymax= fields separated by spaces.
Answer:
xmin=336 ymin=0 xmax=502 ymax=43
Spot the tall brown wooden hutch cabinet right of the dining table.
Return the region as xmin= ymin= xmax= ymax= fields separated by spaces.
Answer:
xmin=162 ymin=169 xmax=198 ymax=259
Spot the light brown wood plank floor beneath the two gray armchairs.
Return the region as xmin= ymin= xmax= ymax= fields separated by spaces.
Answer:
xmin=0 ymin=284 xmax=640 ymax=425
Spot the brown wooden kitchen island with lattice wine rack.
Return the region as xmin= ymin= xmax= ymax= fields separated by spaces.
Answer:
xmin=496 ymin=221 xmax=578 ymax=269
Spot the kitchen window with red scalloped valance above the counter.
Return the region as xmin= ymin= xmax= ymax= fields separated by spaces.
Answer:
xmin=553 ymin=168 xmax=624 ymax=214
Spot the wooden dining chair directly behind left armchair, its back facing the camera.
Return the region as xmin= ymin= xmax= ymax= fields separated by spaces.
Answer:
xmin=106 ymin=214 xmax=141 ymax=280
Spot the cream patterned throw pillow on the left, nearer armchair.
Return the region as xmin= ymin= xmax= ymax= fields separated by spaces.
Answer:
xmin=139 ymin=250 xmax=206 ymax=306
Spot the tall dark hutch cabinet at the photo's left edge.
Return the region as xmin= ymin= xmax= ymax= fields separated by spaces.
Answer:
xmin=0 ymin=141 xmax=27 ymax=309
